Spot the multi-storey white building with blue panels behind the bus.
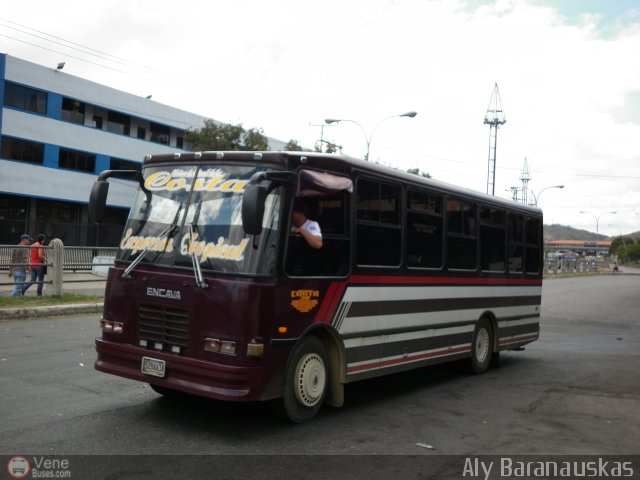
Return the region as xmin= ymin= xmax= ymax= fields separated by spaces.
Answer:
xmin=0 ymin=54 xmax=283 ymax=246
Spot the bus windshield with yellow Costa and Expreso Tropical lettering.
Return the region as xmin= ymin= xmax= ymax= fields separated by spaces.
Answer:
xmin=118 ymin=165 xmax=281 ymax=275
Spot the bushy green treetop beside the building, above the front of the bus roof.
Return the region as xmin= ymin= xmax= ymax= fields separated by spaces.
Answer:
xmin=185 ymin=119 xmax=269 ymax=152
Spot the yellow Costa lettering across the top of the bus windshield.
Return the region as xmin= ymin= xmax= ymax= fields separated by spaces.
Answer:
xmin=144 ymin=170 xmax=248 ymax=193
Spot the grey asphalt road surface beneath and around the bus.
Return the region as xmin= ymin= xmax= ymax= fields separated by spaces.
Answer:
xmin=0 ymin=275 xmax=640 ymax=474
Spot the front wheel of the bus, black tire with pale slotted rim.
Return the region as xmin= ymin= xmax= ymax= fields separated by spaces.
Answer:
xmin=279 ymin=336 xmax=329 ymax=423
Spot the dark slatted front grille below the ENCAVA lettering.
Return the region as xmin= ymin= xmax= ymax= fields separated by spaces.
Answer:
xmin=138 ymin=304 xmax=189 ymax=347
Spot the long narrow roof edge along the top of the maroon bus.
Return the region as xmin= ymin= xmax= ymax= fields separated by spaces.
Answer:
xmin=144 ymin=151 xmax=542 ymax=215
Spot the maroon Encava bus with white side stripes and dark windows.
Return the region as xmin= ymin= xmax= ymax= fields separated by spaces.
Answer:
xmin=89 ymin=152 xmax=543 ymax=422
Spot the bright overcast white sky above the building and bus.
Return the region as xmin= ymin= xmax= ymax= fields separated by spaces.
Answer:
xmin=0 ymin=0 xmax=640 ymax=235
